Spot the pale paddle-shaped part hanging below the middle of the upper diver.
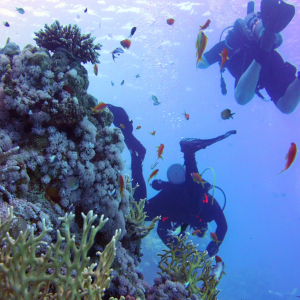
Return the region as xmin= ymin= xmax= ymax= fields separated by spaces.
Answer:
xmin=234 ymin=60 xmax=261 ymax=105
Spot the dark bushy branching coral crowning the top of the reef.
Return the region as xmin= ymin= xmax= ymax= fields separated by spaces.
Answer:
xmin=34 ymin=20 xmax=102 ymax=64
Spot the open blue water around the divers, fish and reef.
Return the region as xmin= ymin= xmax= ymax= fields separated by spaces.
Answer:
xmin=0 ymin=0 xmax=300 ymax=300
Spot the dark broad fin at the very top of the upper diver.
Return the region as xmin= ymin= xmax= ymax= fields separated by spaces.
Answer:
xmin=260 ymin=0 xmax=295 ymax=33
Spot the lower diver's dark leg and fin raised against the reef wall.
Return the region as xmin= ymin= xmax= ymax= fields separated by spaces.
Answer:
xmin=107 ymin=104 xmax=147 ymax=201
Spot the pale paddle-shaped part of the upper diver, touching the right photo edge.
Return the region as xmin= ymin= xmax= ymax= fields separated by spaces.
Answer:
xmin=277 ymin=76 xmax=300 ymax=114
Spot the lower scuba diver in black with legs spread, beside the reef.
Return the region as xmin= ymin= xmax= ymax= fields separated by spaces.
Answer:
xmin=107 ymin=104 xmax=236 ymax=256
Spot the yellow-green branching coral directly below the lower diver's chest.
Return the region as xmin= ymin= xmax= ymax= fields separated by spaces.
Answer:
xmin=158 ymin=235 xmax=223 ymax=300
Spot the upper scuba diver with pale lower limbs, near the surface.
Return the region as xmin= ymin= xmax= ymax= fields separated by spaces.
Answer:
xmin=197 ymin=0 xmax=300 ymax=114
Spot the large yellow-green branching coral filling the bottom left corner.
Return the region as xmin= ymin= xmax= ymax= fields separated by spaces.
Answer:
xmin=0 ymin=208 xmax=120 ymax=300
